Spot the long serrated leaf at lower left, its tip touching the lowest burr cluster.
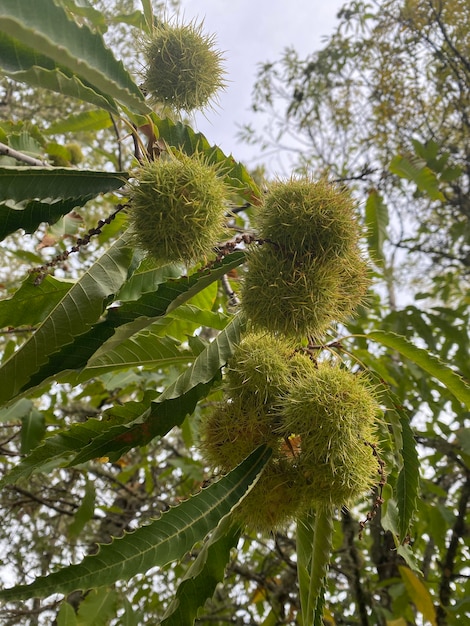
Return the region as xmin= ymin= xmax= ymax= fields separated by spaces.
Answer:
xmin=0 ymin=446 xmax=271 ymax=601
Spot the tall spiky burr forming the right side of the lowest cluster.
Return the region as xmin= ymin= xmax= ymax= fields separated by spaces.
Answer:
xmin=279 ymin=363 xmax=380 ymax=506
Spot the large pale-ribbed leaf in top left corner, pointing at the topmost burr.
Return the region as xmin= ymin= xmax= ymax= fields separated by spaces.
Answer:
xmin=0 ymin=0 xmax=150 ymax=114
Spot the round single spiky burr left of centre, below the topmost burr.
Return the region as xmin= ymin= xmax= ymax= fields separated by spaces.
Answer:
xmin=129 ymin=153 xmax=227 ymax=263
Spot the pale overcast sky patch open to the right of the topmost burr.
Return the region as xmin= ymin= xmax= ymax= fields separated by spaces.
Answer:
xmin=176 ymin=0 xmax=346 ymax=173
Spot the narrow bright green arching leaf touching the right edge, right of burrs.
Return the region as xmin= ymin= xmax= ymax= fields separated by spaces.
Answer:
xmin=366 ymin=330 xmax=470 ymax=408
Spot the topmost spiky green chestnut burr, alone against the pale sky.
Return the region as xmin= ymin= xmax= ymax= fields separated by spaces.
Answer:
xmin=143 ymin=22 xmax=225 ymax=112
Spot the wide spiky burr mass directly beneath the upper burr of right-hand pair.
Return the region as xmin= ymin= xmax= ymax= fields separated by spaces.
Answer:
xmin=241 ymin=243 xmax=369 ymax=341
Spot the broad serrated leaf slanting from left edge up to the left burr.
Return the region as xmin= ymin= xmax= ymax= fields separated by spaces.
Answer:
xmin=0 ymin=232 xmax=133 ymax=402
